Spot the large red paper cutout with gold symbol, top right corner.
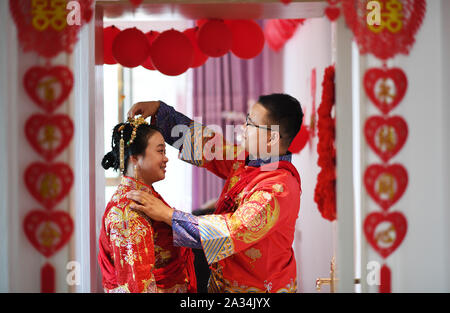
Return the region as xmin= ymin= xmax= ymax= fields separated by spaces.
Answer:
xmin=342 ymin=0 xmax=426 ymax=60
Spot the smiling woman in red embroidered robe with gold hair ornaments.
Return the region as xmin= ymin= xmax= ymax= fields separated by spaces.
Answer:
xmin=98 ymin=117 xmax=196 ymax=293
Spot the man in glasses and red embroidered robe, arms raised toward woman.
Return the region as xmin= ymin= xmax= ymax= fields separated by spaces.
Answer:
xmin=127 ymin=94 xmax=303 ymax=292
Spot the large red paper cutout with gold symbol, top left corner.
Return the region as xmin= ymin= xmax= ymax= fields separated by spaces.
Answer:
xmin=9 ymin=0 xmax=94 ymax=58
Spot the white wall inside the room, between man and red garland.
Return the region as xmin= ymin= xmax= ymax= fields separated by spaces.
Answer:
xmin=283 ymin=18 xmax=333 ymax=292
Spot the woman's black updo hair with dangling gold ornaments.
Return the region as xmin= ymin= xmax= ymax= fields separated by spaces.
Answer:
xmin=102 ymin=123 xmax=161 ymax=175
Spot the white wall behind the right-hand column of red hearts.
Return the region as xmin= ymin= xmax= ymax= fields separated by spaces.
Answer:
xmin=361 ymin=0 xmax=450 ymax=292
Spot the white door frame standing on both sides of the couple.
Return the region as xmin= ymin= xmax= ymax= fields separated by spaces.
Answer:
xmin=74 ymin=2 xmax=355 ymax=292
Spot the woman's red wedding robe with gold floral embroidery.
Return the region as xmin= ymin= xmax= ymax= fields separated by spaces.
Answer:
xmin=98 ymin=177 xmax=196 ymax=293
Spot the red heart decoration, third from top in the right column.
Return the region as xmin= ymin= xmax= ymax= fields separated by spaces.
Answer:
xmin=364 ymin=164 xmax=408 ymax=210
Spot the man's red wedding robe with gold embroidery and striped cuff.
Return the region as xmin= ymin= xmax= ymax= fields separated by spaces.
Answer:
xmin=180 ymin=122 xmax=301 ymax=293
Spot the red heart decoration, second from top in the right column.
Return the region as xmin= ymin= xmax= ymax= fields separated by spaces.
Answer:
xmin=364 ymin=116 xmax=408 ymax=162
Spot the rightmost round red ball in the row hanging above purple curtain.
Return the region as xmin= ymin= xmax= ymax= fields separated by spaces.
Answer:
xmin=226 ymin=20 xmax=264 ymax=59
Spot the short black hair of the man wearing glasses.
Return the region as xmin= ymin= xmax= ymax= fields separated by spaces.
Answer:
xmin=258 ymin=93 xmax=303 ymax=147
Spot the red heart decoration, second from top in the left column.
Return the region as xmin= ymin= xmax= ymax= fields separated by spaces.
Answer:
xmin=25 ymin=114 xmax=73 ymax=162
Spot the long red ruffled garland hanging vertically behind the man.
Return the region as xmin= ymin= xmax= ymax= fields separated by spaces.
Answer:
xmin=314 ymin=66 xmax=336 ymax=221
